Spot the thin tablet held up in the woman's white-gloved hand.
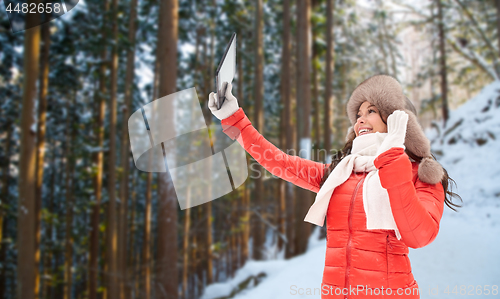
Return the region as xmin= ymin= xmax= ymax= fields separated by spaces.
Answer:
xmin=215 ymin=33 xmax=236 ymax=109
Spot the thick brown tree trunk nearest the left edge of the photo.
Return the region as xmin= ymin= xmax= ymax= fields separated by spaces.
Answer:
xmin=17 ymin=0 xmax=40 ymax=299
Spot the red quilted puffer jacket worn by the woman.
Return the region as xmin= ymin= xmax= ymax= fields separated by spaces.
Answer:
xmin=222 ymin=108 xmax=445 ymax=299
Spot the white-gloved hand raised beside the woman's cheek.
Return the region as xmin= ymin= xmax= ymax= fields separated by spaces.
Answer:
xmin=376 ymin=110 xmax=408 ymax=156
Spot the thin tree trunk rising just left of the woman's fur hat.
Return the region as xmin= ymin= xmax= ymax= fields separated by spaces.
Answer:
xmin=323 ymin=0 xmax=335 ymax=163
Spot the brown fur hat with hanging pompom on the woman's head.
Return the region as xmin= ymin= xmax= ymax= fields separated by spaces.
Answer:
xmin=347 ymin=75 xmax=444 ymax=184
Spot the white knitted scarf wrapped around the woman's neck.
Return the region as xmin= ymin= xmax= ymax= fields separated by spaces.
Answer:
xmin=304 ymin=132 xmax=401 ymax=240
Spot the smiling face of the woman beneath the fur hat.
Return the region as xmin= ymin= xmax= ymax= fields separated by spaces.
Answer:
xmin=354 ymin=101 xmax=387 ymax=137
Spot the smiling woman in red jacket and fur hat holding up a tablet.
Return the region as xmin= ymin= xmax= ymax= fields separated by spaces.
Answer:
xmin=209 ymin=75 xmax=457 ymax=299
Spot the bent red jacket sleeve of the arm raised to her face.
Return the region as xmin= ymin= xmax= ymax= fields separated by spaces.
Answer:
xmin=374 ymin=148 xmax=445 ymax=248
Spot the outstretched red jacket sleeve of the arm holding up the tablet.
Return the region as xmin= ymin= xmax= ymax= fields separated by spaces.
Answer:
xmin=221 ymin=108 xmax=326 ymax=192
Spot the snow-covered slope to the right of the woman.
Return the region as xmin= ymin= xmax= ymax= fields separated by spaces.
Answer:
xmin=410 ymin=81 xmax=500 ymax=298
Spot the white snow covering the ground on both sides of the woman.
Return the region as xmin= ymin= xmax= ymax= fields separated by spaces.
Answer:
xmin=202 ymin=82 xmax=500 ymax=299
